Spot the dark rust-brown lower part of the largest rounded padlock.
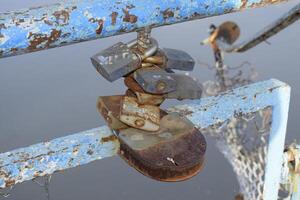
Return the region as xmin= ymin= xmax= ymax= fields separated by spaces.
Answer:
xmin=119 ymin=129 xmax=206 ymax=182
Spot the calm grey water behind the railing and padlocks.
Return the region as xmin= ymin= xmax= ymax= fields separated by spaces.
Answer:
xmin=0 ymin=0 xmax=300 ymax=200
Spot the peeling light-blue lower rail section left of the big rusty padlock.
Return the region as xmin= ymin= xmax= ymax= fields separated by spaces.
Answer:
xmin=0 ymin=127 xmax=120 ymax=188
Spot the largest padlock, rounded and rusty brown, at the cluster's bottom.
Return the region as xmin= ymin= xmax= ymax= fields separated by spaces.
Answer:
xmin=116 ymin=113 xmax=206 ymax=182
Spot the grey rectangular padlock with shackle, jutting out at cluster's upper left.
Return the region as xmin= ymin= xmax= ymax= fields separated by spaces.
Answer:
xmin=91 ymin=38 xmax=158 ymax=82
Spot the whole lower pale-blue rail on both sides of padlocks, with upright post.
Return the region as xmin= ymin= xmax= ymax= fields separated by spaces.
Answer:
xmin=0 ymin=80 xmax=290 ymax=200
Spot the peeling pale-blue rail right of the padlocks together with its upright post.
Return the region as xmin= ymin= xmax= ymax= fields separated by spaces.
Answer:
xmin=172 ymin=80 xmax=290 ymax=200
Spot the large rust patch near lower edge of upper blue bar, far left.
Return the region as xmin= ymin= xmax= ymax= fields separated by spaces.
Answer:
xmin=28 ymin=29 xmax=62 ymax=51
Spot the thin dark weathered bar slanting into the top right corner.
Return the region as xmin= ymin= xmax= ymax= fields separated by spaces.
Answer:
xmin=218 ymin=3 xmax=300 ymax=53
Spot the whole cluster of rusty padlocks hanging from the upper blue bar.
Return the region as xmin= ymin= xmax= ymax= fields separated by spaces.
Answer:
xmin=91 ymin=28 xmax=206 ymax=181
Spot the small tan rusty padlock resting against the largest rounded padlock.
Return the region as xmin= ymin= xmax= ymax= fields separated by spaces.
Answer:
xmin=120 ymin=96 xmax=160 ymax=132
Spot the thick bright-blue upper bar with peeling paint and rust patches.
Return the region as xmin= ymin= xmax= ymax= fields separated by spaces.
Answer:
xmin=0 ymin=0 xmax=287 ymax=58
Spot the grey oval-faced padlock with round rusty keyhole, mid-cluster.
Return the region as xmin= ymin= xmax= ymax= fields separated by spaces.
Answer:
xmin=133 ymin=67 xmax=176 ymax=94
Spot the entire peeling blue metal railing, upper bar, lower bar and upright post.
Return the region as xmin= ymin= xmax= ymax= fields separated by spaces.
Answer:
xmin=0 ymin=0 xmax=300 ymax=200
